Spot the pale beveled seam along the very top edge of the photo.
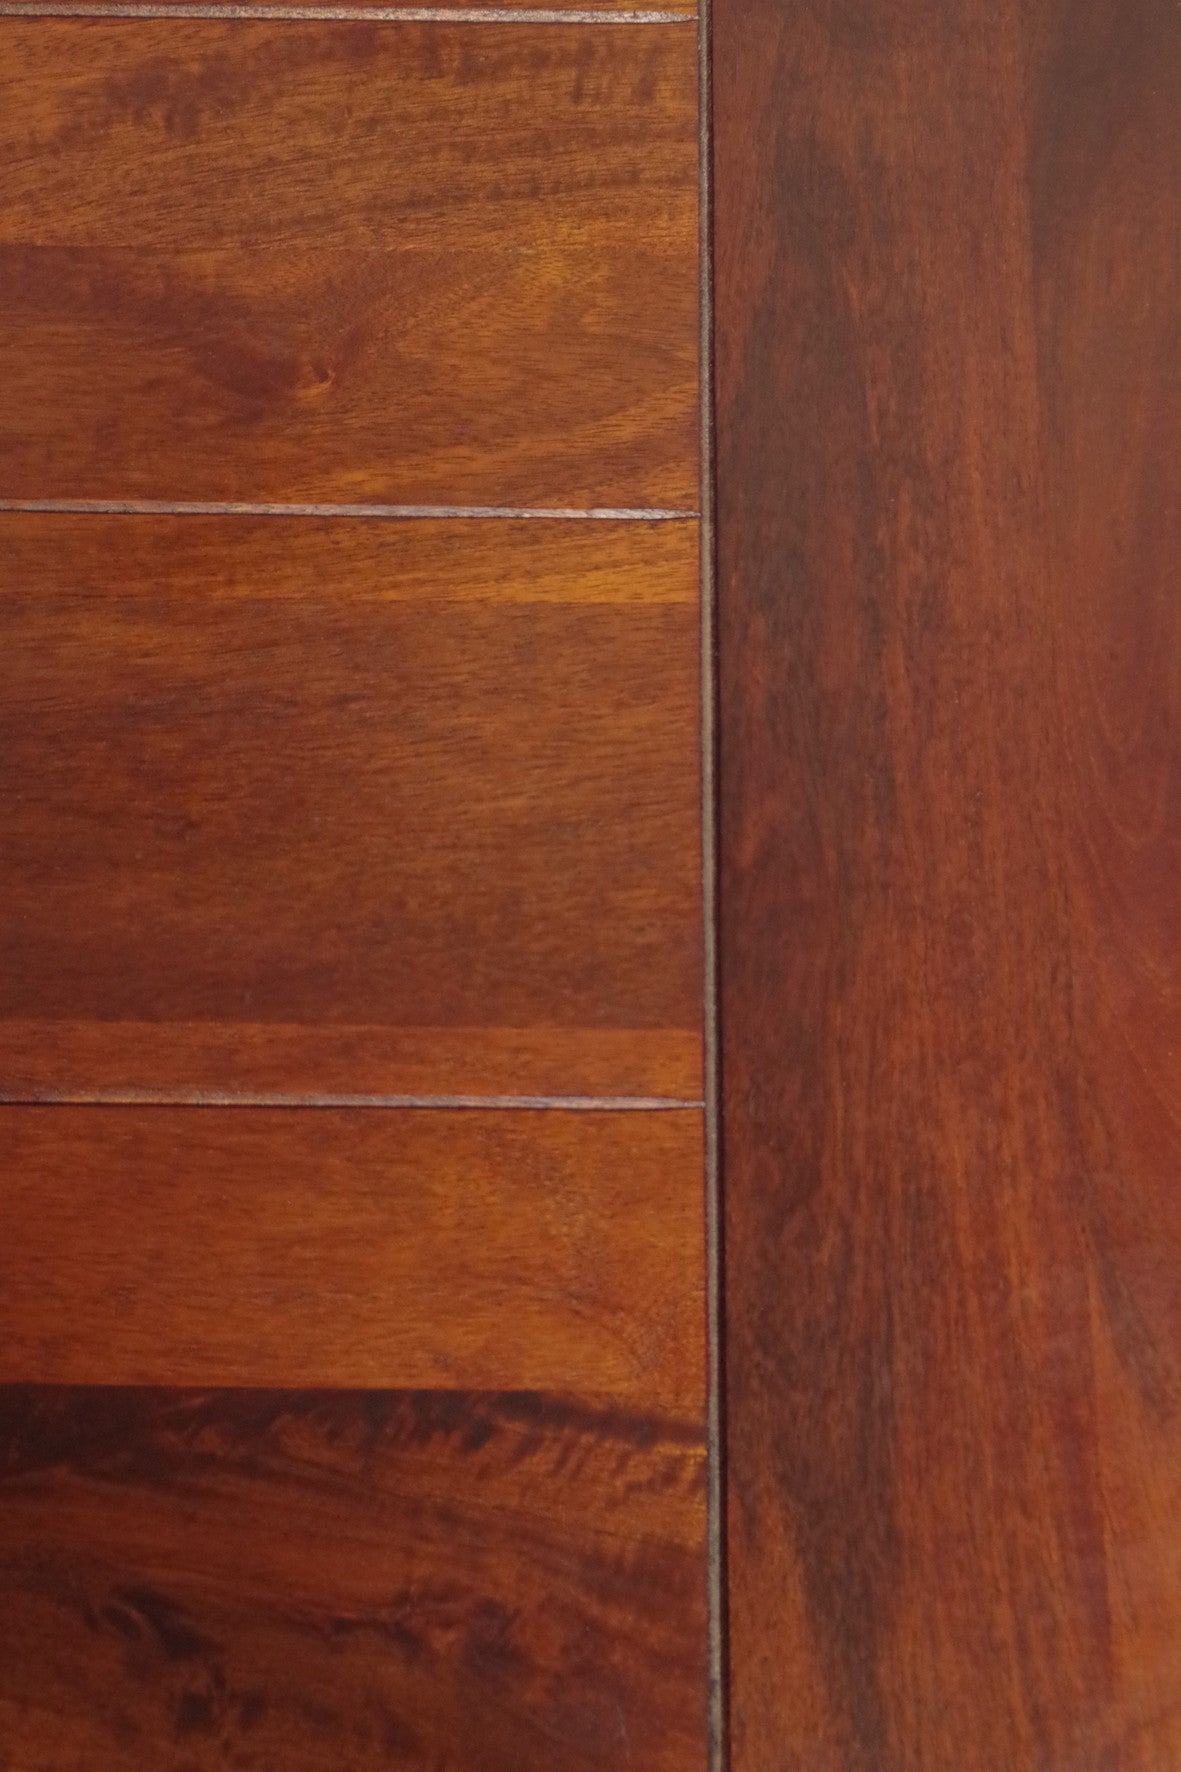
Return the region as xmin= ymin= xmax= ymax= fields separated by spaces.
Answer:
xmin=0 ymin=0 xmax=697 ymax=25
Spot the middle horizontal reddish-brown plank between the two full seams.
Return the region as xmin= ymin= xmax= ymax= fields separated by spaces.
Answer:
xmin=0 ymin=514 xmax=700 ymax=1100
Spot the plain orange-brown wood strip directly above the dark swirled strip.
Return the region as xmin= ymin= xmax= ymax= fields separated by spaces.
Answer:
xmin=0 ymin=1108 xmax=704 ymax=1412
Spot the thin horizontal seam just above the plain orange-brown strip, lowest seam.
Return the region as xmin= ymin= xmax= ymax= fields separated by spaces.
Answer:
xmin=0 ymin=1090 xmax=704 ymax=1113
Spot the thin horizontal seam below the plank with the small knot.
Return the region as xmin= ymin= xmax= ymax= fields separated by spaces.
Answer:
xmin=0 ymin=499 xmax=699 ymax=523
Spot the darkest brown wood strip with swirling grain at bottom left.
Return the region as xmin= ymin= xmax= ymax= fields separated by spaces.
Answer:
xmin=0 ymin=1389 xmax=706 ymax=1772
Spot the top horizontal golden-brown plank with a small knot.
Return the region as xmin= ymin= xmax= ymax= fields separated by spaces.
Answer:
xmin=0 ymin=18 xmax=697 ymax=509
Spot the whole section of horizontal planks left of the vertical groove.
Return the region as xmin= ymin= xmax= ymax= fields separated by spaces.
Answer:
xmin=0 ymin=0 xmax=709 ymax=1772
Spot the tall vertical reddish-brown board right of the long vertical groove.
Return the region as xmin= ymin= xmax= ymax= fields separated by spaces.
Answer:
xmin=715 ymin=0 xmax=1181 ymax=1772
